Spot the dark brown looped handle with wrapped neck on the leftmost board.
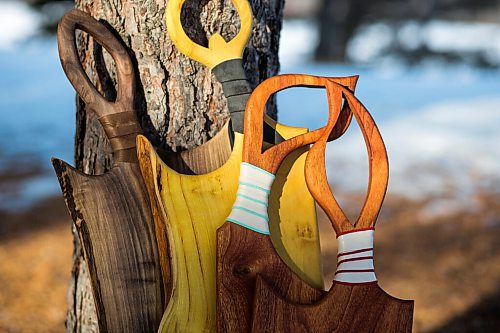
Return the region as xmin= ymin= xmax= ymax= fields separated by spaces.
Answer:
xmin=57 ymin=9 xmax=142 ymax=163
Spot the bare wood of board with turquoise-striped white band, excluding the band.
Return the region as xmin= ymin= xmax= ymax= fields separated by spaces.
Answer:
xmin=217 ymin=75 xmax=356 ymax=332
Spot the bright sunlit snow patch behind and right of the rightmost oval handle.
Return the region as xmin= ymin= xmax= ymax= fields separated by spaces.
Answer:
xmin=327 ymin=97 xmax=500 ymax=204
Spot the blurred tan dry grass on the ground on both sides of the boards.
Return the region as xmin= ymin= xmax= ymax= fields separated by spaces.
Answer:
xmin=0 ymin=193 xmax=500 ymax=332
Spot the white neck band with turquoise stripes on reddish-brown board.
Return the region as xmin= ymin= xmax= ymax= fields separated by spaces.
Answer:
xmin=227 ymin=162 xmax=275 ymax=235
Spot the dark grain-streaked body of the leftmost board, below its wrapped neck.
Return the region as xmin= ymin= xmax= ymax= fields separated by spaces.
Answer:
xmin=53 ymin=159 xmax=165 ymax=333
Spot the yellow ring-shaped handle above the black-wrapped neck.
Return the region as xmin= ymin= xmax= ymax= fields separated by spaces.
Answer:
xmin=165 ymin=0 xmax=252 ymax=68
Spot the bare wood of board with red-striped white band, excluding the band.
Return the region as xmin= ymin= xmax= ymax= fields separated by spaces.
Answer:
xmin=252 ymin=88 xmax=413 ymax=333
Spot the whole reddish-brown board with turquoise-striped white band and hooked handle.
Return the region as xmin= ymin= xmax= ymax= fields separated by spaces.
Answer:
xmin=217 ymin=74 xmax=358 ymax=332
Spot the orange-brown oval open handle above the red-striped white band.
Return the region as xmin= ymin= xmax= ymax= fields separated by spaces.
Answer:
xmin=305 ymin=85 xmax=389 ymax=233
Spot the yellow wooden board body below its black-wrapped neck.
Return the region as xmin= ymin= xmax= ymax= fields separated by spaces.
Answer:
xmin=137 ymin=125 xmax=323 ymax=333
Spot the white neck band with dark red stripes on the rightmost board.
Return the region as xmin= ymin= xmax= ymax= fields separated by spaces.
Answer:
xmin=334 ymin=229 xmax=377 ymax=284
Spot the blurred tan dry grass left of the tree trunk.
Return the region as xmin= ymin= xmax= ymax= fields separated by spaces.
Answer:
xmin=0 ymin=198 xmax=73 ymax=332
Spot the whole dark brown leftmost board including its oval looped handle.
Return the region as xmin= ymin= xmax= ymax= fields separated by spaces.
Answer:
xmin=53 ymin=10 xmax=164 ymax=332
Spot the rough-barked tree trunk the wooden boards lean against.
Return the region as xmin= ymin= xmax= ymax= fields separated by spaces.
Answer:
xmin=66 ymin=0 xmax=284 ymax=332
